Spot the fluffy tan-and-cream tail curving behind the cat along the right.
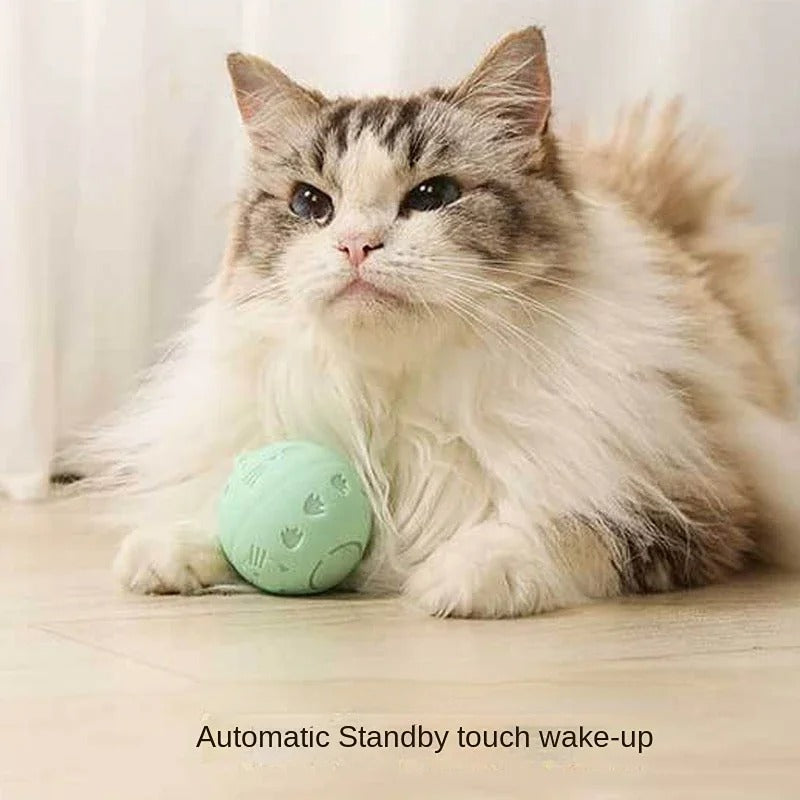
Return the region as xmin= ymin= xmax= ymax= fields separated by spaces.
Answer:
xmin=568 ymin=99 xmax=800 ymax=569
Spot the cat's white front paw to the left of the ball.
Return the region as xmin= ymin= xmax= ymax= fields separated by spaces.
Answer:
xmin=113 ymin=526 xmax=241 ymax=594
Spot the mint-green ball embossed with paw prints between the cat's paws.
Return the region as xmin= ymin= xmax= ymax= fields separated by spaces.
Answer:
xmin=219 ymin=441 xmax=372 ymax=594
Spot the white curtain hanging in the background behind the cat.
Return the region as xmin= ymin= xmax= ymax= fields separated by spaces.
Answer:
xmin=0 ymin=0 xmax=800 ymax=498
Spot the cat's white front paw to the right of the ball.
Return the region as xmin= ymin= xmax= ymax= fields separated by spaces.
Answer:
xmin=404 ymin=523 xmax=561 ymax=618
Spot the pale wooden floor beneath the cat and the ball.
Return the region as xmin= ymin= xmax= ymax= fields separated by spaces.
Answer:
xmin=0 ymin=496 xmax=800 ymax=800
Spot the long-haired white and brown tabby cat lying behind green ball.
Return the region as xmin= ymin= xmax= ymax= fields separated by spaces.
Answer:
xmin=69 ymin=27 xmax=800 ymax=617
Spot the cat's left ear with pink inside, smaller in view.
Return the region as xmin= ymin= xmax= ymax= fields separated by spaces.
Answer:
xmin=228 ymin=53 xmax=325 ymax=140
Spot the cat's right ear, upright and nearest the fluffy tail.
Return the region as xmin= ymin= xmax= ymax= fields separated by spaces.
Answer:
xmin=454 ymin=27 xmax=550 ymax=136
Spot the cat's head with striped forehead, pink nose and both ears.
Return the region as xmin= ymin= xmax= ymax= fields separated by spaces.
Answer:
xmin=224 ymin=28 xmax=577 ymax=350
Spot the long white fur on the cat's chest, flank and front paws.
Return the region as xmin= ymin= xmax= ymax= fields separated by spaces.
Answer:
xmin=69 ymin=186 xmax=794 ymax=616
